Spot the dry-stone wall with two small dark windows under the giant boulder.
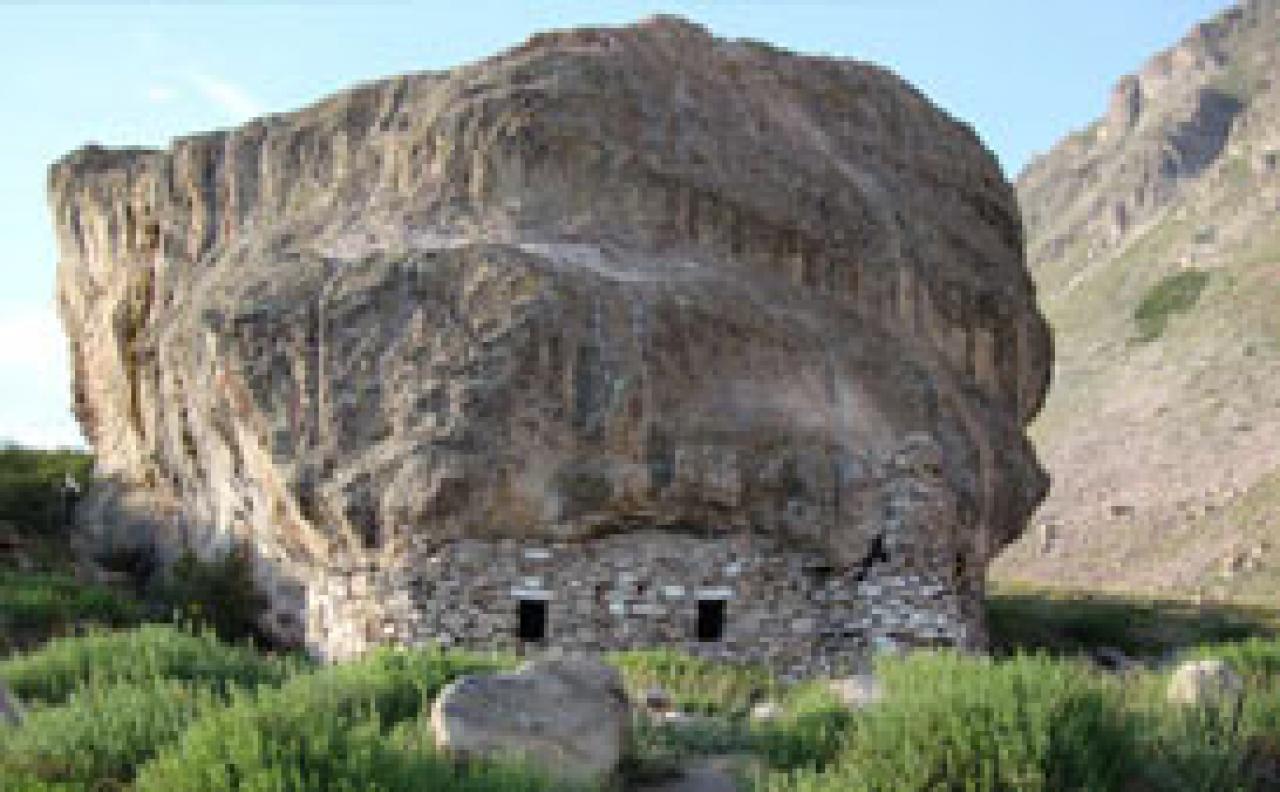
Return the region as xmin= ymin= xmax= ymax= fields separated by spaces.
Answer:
xmin=307 ymin=530 xmax=980 ymax=677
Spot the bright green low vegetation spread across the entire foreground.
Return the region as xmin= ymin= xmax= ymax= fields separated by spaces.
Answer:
xmin=0 ymin=626 xmax=1280 ymax=792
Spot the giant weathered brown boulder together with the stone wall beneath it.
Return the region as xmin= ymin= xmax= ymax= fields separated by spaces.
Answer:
xmin=50 ymin=18 xmax=1051 ymax=669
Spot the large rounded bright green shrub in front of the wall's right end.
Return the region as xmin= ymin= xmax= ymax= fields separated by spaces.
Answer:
xmin=764 ymin=654 xmax=1139 ymax=792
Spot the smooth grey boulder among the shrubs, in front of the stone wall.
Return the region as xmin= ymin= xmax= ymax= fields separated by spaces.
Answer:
xmin=431 ymin=659 xmax=631 ymax=782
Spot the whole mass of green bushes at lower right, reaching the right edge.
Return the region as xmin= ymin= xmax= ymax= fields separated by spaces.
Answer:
xmin=758 ymin=654 xmax=1280 ymax=792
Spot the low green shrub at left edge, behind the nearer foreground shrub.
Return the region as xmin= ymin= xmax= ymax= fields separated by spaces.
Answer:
xmin=0 ymin=624 xmax=297 ymax=702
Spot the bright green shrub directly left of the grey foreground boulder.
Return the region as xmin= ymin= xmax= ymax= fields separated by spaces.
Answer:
xmin=136 ymin=650 xmax=509 ymax=792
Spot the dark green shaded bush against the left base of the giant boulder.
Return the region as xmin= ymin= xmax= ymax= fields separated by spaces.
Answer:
xmin=148 ymin=548 xmax=268 ymax=641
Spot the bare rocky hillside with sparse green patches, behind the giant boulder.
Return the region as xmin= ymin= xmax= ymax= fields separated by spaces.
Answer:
xmin=997 ymin=0 xmax=1280 ymax=596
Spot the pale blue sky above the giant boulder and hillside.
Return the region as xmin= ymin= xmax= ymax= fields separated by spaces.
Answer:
xmin=0 ymin=0 xmax=1228 ymax=445
